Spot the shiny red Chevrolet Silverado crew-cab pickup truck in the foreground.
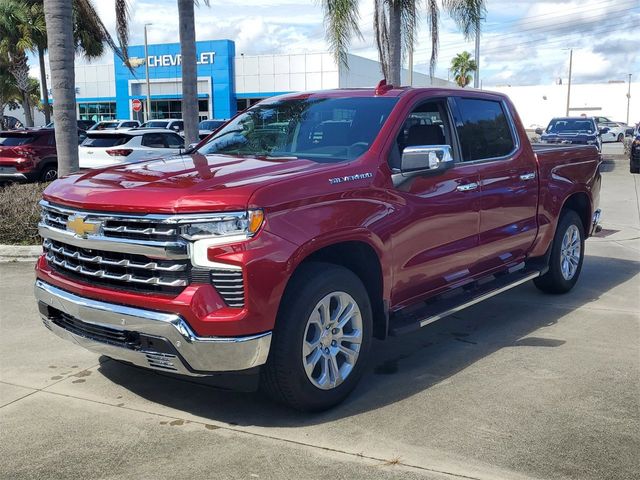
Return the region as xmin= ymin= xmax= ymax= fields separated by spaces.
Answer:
xmin=35 ymin=82 xmax=600 ymax=411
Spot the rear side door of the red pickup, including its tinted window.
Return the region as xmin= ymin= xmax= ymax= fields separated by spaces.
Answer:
xmin=454 ymin=96 xmax=538 ymax=272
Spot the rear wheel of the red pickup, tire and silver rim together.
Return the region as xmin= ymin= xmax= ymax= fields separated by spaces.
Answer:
xmin=533 ymin=210 xmax=584 ymax=294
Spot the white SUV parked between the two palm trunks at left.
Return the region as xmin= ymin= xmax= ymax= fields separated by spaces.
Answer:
xmin=79 ymin=129 xmax=184 ymax=168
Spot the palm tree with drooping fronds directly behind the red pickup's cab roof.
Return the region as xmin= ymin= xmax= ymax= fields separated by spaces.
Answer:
xmin=322 ymin=0 xmax=485 ymax=85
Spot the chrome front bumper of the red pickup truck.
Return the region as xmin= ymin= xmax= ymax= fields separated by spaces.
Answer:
xmin=35 ymin=280 xmax=271 ymax=376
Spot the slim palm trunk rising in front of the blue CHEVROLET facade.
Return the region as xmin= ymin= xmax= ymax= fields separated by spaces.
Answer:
xmin=178 ymin=0 xmax=198 ymax=145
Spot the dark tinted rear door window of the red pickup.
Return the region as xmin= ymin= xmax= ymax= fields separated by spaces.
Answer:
xmin=456 ymin=98 xmax=515 ymax=162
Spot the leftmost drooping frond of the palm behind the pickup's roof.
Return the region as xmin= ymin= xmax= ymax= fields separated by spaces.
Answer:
xmin=322 ymin=0 xmax=362 ymax=67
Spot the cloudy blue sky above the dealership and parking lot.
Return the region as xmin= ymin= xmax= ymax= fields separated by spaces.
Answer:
xmin=82 ymin=0 xmax=640 ymax=86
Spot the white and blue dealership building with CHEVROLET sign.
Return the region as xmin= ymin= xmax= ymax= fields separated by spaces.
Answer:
xmin=40 ymin=40 xmax=452 ymax=121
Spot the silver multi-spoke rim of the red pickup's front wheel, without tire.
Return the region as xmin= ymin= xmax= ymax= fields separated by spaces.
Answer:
xmin=302 ymin=292 xmax=362 ymax=390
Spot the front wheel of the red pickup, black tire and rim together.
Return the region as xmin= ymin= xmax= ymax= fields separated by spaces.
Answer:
xmin=261 ymin=262 xmax=373 ymax=411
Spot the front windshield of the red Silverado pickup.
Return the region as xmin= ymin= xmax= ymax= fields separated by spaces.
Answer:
xmin=198 ymin=97 xmax=397 ymax=162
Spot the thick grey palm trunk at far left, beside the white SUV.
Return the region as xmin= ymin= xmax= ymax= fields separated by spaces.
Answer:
xmin=44 ymin=0 xmax=78 ymax=176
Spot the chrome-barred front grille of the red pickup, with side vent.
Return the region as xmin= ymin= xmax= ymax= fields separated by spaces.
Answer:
xmin=40 ymin=201 xmax=245 ymax=308
